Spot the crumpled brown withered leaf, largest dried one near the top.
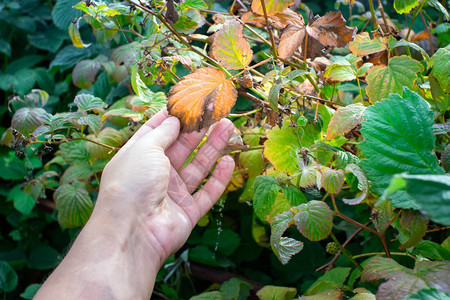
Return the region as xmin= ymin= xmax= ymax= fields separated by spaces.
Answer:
xmin=278 ymin=11 xmax=357 ymax=58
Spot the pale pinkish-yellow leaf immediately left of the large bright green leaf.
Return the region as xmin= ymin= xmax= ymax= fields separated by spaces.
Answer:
xmin=327 ymin=104 xmax=366 ymax=141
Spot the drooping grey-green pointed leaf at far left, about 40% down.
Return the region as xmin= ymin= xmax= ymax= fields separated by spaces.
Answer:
xmin=11 ymin=107 xmax=46 ymax=137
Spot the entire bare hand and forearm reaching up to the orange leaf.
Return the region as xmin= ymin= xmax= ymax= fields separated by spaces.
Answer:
xmin=34 ymin=110 xmax=234 ymax=300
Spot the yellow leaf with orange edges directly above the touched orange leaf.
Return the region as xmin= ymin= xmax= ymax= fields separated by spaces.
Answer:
xmin=211 ymin=20 xmax=253 ymax=70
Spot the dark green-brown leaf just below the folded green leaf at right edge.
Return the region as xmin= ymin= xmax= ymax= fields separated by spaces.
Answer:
xmin=392 ymin=210 xmax=428 ymax=250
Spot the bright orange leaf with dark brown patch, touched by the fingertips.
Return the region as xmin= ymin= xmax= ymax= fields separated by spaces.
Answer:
xmin=167 ymin=68 xmax=237 ymax=132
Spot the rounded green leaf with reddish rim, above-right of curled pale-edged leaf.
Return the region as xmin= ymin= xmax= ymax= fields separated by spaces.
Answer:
xmin=294 ymin=200 xmax=333 ymax=241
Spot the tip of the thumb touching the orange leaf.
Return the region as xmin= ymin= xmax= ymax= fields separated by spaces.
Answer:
xmin=142 ymin=117 xmax=180 ymax=149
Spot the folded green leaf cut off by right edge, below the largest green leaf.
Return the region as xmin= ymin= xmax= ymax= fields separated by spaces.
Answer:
xmin=386 ymin=174 xmax=450 ymax=226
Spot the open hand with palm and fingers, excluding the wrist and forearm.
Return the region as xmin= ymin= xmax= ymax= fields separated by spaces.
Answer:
xmin=93 ymin=110 xmax=234 ymax=264
